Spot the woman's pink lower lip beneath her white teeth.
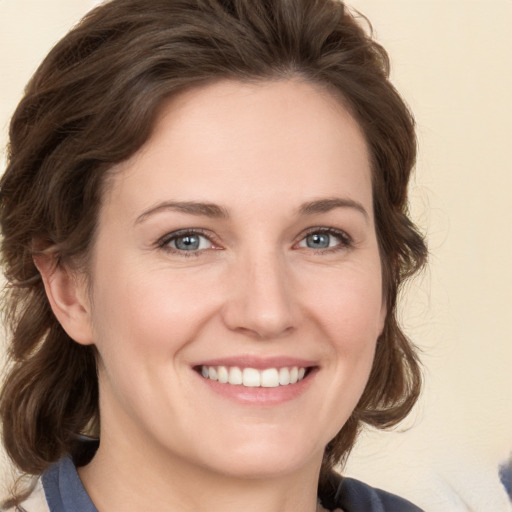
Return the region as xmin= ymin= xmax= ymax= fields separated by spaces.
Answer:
xmin=198 ymin=369 xmax=316 ymax=406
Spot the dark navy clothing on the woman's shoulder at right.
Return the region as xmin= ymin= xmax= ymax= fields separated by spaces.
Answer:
xmin=335 ymin=477 xmax=422 ymax=512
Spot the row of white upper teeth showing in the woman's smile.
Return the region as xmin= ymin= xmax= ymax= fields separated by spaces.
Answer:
xmin=201 ymin=366 xmax=306 ymax=388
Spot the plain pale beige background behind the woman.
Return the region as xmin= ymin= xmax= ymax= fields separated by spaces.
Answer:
xmin=0 ymin=0 xmax=512 ymax=512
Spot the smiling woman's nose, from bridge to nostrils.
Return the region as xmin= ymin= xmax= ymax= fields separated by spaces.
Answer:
xmin=223 ymin=251 xmax=299 ymax=340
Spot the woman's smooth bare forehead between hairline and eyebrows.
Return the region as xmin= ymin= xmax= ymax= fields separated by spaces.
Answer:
xmin=102 ymin=80 xmax=371 ymax=216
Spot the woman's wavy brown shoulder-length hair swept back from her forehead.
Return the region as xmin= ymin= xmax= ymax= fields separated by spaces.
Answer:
xmin=0 ymin=0 xmax=426 ymax=490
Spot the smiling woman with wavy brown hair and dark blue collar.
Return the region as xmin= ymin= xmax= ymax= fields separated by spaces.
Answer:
xmin=0 ymin=0 xmax=426 ymax=512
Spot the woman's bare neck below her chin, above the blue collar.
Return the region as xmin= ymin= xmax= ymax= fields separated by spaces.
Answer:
xmin=79 ymin=428 xmax=321 ymax=512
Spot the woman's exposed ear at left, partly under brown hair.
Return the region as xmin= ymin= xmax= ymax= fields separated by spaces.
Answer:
xmin=33 ymin=253 xmax=93 ymax=345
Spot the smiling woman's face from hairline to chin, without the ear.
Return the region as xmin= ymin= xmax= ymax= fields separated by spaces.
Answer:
xmin=81 ymin=81 xmax=385 ymax=476
